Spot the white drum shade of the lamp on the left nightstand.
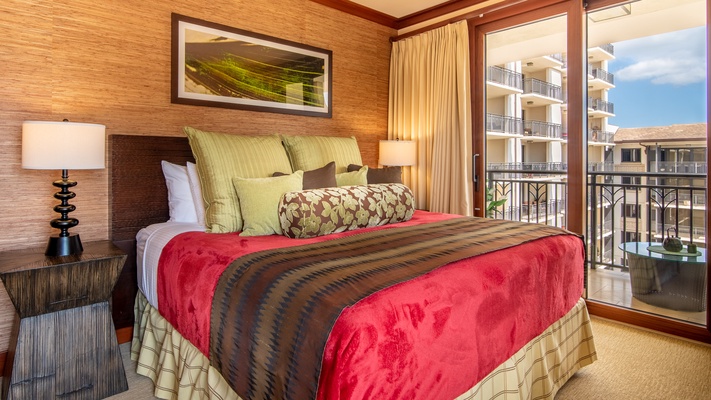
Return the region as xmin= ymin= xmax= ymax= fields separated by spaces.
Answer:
xmin=22 ymin=121 xmax=106 ymax=169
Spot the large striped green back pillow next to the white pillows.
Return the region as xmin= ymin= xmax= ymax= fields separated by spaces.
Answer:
xmin=183 ymin=126 xmax=291 ymax=233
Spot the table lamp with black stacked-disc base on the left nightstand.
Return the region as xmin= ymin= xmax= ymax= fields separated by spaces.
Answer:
xmin=22 ymin=120 xmax=106 ymax=256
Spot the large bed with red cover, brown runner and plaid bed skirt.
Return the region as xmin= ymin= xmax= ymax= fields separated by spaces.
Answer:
xmin=110 ymin=130 xmax=596 ymax=399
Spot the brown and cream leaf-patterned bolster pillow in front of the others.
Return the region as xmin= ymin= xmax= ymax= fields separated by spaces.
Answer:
xmin=279 ymin=183 xmax=415 ymax=238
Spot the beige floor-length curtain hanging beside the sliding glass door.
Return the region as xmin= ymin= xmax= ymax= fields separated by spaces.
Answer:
xmin=388 ymin=21 xmax=473 ymax=215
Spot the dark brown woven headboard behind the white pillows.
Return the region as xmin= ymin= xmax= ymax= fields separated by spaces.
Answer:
xmin=109 ymin=135 xmax=195 ymax=329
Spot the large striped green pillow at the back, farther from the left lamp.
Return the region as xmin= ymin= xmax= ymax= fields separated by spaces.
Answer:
xmin=276 ymin=135 xmax=363 ymax=174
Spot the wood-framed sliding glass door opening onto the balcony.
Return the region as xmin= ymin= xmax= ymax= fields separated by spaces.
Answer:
xmin=470 ymin=0 xmax=711 ymax=342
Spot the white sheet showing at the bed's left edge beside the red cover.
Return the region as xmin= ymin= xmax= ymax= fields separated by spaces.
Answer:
xmin=136 ymin=222 xmax=205 ymax=309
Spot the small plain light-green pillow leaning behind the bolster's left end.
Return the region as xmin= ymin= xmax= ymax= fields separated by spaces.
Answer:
xmin=232 ymin=171 xmax=304 ymax=236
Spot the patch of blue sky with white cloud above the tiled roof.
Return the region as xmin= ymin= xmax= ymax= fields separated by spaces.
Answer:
xmin=608 ymin=26 xmax=706 ymax=128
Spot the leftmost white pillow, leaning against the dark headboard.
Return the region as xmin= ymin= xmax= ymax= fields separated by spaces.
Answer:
xmin=161 ymin=160 xmax=197 ymax=223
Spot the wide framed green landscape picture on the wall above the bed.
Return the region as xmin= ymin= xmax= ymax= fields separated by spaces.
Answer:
xmin=171 ymin=13 xmax=332 ymax=118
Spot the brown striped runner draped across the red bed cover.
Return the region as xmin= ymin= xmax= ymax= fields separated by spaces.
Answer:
xmin=210 ymin=218 xmax=570 ymax=399
